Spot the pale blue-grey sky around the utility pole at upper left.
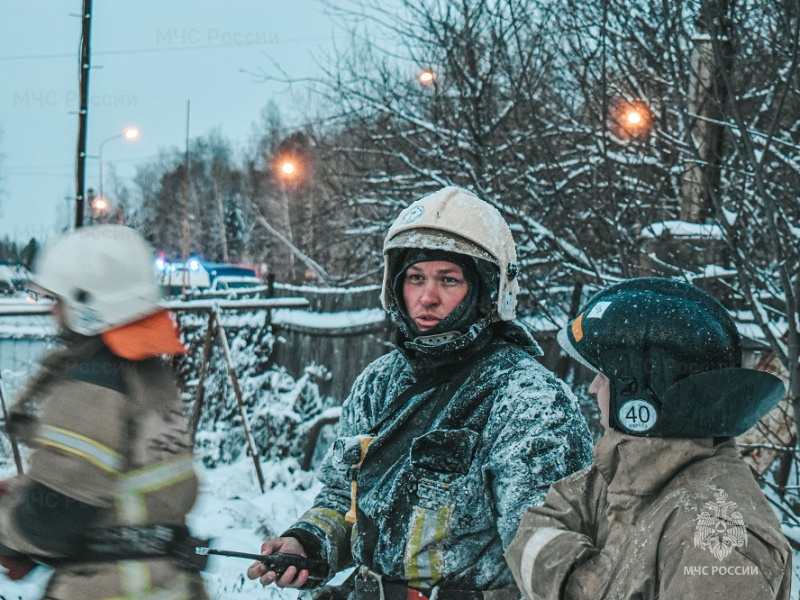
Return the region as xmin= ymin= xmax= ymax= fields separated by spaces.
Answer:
xmin=0 ymin=0 xmax=341 ymax=242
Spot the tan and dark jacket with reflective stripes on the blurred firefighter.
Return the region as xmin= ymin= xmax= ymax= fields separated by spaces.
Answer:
xmin=0 ymin=337 xmax=206 ymax=600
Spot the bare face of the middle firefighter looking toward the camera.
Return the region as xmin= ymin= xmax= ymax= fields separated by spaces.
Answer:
xmin=403 ymin=260 xmax=469 ymax=331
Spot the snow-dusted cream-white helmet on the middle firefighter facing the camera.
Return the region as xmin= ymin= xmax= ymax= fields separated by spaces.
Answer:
xmin=381 ymin=187 xmax=519 ymax=321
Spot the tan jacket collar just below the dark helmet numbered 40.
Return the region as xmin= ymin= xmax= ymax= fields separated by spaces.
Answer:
xmin=594 ymin=431 xmax=738 ymax=496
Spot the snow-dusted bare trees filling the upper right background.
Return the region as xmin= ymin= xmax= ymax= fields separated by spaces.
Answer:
xmin=296 ymin=0 xmax=800 ymax=524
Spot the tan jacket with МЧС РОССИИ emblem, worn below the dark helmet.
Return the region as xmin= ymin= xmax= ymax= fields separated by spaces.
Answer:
xmin=506 ymin=432 xmax=792 ymax=600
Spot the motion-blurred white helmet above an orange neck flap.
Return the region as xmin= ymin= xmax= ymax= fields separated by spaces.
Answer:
xmin=32 ymin=225 xmax=161 ymax=335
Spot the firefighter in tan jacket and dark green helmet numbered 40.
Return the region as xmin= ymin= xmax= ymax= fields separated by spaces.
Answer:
xmin=506 ymin=278 xmax=792 ymax=600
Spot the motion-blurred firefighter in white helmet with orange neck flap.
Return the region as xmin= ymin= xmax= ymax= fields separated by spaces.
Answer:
xmin=0 ymin=225 xmax=206 ymax=600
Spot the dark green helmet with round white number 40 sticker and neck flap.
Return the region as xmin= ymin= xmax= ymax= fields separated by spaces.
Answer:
xmin=558 ymin=278 xmax=784 ymax=438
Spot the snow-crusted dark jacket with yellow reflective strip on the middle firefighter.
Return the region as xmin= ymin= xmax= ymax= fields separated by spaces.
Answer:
xmin=285 ymin=326 xmax=591 ymax=590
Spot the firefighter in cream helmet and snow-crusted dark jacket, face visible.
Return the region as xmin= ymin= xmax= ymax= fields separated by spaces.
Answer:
xmin=248 ymin=187 xmax=591 ymax=600
